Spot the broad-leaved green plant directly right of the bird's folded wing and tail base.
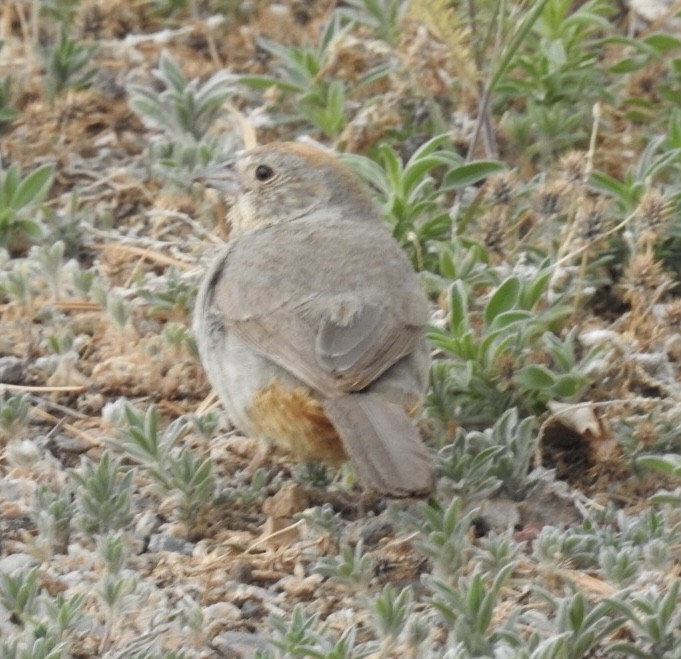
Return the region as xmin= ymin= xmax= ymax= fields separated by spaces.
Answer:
xmin=426 ymin=266 xmax=602 ymax=426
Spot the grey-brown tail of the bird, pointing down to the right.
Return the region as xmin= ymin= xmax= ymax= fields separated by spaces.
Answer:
xmin=324 ymin=393 xmax=435 ymax=497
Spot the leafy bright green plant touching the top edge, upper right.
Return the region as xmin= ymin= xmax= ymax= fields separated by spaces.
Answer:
xmin=487 ymin=0 xmax=612 ymax=160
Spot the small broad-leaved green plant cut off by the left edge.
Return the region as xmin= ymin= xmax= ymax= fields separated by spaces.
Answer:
xmin=0 ymin=163 xmax=54 ymax=251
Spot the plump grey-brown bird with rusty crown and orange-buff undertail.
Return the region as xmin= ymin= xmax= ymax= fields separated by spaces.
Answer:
xmin=193 ymin=142 xmax=436 ymax=498
